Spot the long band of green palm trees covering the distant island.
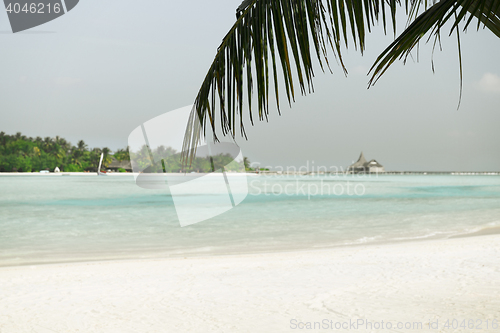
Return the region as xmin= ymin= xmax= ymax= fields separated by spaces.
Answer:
xmin=0 ymin=132 xmax=264 ymax=172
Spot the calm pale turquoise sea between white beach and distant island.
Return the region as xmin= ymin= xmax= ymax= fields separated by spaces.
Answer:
xmin=0 ymin=175 xmax=500 ymax=266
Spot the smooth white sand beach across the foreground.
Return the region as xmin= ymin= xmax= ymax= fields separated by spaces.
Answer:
xmin=0 ymin=235 xmax=500 ymax=333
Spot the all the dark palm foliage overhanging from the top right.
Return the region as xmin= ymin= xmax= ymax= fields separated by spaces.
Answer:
xmin=183 ymin=0 xmax=500 ymax=158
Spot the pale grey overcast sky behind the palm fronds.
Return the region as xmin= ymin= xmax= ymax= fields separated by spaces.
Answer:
xmin=0 ymin=0 xmax=500 ymax=171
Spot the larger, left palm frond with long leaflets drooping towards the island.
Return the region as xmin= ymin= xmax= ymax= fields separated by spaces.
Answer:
xmin=183 ymin=0 xmax=396 ymax=160
